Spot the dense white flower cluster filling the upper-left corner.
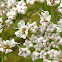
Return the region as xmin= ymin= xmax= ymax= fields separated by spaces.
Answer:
xmin=0 ymin=0 xmax=27 ymax=24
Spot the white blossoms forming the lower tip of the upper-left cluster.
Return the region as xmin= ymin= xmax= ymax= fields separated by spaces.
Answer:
xmin=5 ymin=7 xmax=17 ymax=24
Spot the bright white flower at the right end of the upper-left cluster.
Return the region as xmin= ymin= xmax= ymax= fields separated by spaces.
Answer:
xmin=17 ymin=0 xmax=27 ymax=14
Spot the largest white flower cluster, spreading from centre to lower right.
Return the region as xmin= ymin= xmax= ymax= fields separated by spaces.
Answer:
xmin=15 ymin=11 xmax=62 ymax=62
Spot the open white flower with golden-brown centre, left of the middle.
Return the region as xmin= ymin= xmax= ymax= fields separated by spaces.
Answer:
xmin=15 ymin=20 xmax=29 ymax=39
